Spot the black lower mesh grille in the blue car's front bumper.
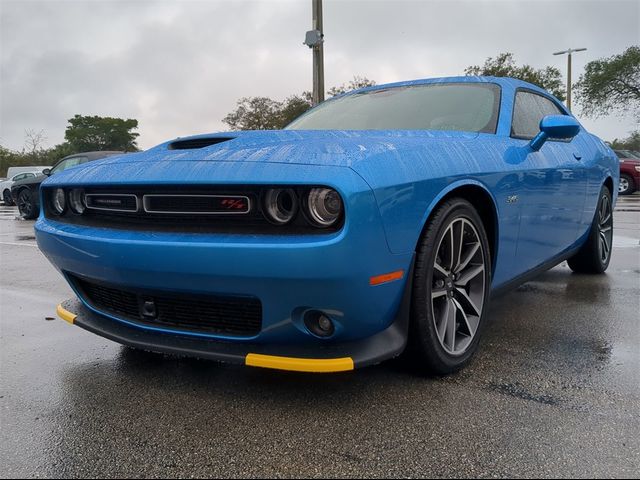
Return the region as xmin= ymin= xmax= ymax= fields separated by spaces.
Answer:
xmin=70 ymin=275 xmax=262 ymax=336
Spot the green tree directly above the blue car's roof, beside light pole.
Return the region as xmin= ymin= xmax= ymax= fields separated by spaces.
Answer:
xmin=464 ymin=52 xmax=566 ymax=101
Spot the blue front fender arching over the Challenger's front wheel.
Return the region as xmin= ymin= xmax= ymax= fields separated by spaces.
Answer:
xmin=354 ymin=134 xmax=522 ymax=285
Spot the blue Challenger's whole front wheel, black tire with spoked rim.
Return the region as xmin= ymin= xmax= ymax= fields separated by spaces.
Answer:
xmin=408 ymin=198 xmax=491 ymax=375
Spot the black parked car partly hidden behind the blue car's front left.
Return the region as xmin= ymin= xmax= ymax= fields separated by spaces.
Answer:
xmin=11 ymin=151 xmax=124 ymax=220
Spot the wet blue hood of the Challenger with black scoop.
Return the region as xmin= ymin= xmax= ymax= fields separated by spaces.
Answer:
xmin=46 ymin=130 xmax=478 ymax=185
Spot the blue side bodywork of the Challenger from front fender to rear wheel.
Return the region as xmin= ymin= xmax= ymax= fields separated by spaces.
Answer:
xmin=352 ymin=83 xmax=617 ymax=287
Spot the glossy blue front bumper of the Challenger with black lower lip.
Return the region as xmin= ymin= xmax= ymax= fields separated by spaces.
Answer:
xmin=35 ymin=166 xmax=413 ymax=366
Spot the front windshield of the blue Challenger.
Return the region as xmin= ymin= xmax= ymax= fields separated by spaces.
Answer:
xmin=286 ymin=83 xmax=500 ymax=133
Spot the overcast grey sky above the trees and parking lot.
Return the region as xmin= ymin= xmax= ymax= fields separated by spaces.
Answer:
xmin=0 ymin=0 xmax=640 ymax=149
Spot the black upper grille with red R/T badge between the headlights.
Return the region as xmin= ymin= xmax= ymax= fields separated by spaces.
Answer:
xmin=44 ymin=185 xmax=344 ymax=235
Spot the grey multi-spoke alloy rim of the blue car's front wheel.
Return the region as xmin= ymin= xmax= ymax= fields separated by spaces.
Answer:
xmin=431 ymin=217 xmax=487 ymax=355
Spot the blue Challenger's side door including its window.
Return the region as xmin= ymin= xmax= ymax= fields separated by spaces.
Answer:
xmin=511 ymin=89 xmax=587 ymax=273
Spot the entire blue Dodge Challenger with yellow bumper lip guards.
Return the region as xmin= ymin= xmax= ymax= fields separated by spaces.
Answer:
xmin=36 ymin=77 xmax=619 ymax=374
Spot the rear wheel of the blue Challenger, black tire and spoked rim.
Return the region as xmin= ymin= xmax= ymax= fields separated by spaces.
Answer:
xmin=567 ymin=185 xmax=613 ymax=273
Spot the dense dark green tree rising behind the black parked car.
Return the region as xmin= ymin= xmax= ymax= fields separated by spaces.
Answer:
xmin=64 ymin=115 xmax=139 ymax=152
